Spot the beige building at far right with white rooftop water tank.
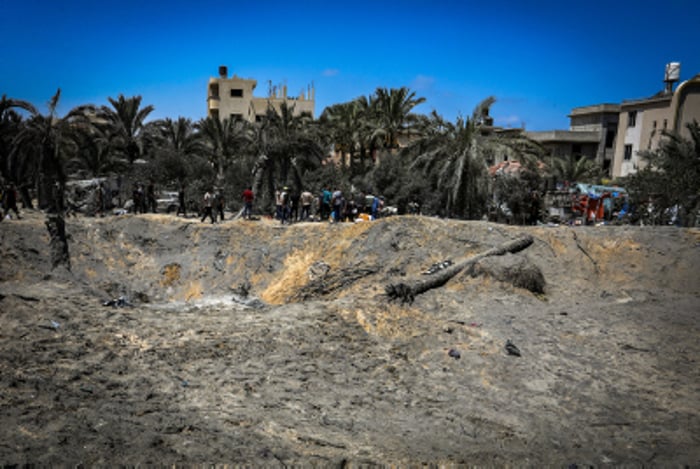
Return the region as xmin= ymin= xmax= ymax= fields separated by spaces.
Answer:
xmin=612 ymin=68 xmax=700 ymax=177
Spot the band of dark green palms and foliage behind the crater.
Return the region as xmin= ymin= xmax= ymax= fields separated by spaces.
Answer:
xmin=0 ymin=87 xmax=700 ymax=223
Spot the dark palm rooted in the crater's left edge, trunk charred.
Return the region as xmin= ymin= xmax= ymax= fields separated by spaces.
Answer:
xmin=13 ymin=89 xmax=90 ymax=270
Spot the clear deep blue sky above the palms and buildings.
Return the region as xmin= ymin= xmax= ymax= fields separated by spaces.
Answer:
xmin=0 ymin=0 xmax=700 ymax=130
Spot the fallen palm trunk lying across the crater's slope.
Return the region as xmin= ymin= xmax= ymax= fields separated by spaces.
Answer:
xmin=384 ymin=235 xmax=533 ymax=303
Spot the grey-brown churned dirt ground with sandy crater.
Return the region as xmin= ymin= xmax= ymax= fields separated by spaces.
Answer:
xmin=0 ymin=212 xmax=700 ymax=467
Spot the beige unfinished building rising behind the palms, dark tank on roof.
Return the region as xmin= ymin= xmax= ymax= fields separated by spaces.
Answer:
xmin=207 ymin=66 xmax=316 ymax=122
